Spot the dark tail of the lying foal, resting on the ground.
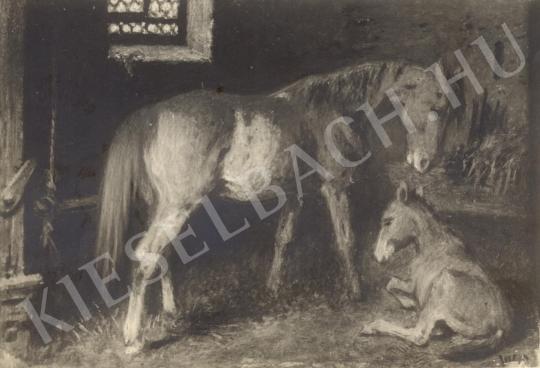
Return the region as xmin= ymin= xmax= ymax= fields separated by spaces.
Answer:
xmin=440 ymin=329 xmax=503 ymax=359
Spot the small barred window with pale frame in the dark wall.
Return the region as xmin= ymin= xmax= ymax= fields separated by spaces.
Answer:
xmin=107 ymin=0 xmax=213 ymax=62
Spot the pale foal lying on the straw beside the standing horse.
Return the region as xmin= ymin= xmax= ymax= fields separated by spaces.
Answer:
xmin=362 ymin=183 xmax=511 ymax=358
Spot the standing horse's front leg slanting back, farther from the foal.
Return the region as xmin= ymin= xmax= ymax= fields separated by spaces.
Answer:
xmin=266 ymin=200 xmax=302 ymax=295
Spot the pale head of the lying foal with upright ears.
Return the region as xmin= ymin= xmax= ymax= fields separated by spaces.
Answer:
xmin=374 ymin=182 xmax=423 ymax=262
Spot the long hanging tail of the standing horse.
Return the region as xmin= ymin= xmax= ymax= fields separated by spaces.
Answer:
xmin=96 ymin=121 xmax=150 ymax=275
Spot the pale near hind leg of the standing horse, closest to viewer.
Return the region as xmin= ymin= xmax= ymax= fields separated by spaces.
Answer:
xmin=124 ymin=206 xmax=189 ymax=353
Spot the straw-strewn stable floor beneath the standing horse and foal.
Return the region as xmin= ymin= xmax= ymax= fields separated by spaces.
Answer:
xmin=20 ymin=293 xmax=538 ymax=368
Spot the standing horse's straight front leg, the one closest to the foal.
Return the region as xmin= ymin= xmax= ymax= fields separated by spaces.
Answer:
xmin=321 ymin=183 xmax=360 ymax=299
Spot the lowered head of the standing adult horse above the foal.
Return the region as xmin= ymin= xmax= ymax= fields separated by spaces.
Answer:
xmin=393 ymin=67 xmax=451 ymax=173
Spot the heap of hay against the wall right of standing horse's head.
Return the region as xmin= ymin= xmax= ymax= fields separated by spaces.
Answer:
xmin=445 ymin=129 xmax=528 ymax=194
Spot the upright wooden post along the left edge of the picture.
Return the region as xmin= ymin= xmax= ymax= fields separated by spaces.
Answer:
xmin=0 ymin=0 xmax=25 ymax=277
